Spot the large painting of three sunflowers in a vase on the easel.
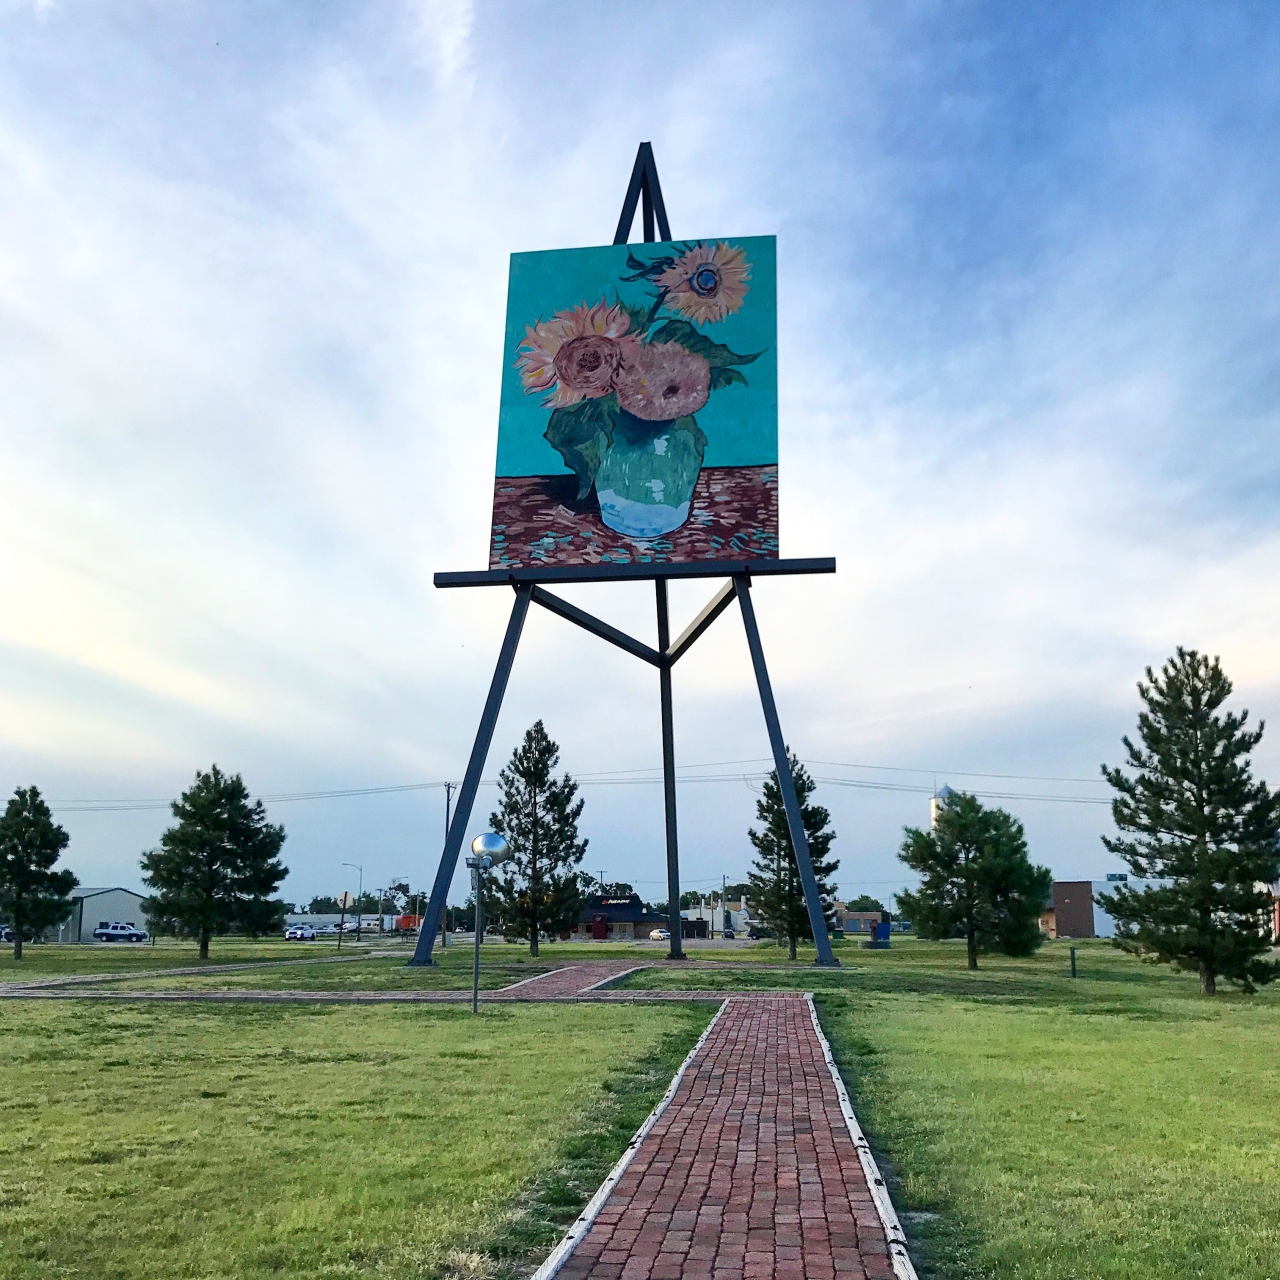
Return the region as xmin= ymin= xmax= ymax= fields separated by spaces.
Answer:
xmin=489 ymin=236 xmax=778 ymax=568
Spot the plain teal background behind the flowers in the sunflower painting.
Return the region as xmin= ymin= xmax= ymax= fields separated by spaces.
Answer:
xmin=495 ymin=236 xmax=778 ymax=476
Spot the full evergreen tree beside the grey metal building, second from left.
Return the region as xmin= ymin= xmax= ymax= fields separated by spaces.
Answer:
xmin=142 ymin=764 xmax=288 ymax=960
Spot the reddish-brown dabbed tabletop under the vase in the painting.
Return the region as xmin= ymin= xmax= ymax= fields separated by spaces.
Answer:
xmin=489 ymin=466 xmax=778 ymax=568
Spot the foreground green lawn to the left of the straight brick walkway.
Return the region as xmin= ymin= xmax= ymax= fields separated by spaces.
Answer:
xmin=0 ymin=1002 xmax=710 ymax=1280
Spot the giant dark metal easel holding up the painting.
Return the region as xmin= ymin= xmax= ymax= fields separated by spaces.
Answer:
xmin=410 ymin=142 xmax=840 ymax=965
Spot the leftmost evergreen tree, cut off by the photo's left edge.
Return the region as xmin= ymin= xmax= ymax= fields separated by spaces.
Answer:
xmin=0 ymin=787 xmax=79 ymax=960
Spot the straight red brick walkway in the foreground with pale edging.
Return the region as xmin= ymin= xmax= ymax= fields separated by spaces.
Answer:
xmin=558 ymin=996 xmax=893 ymax=1280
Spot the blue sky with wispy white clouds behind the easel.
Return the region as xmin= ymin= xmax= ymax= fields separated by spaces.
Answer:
xmin=0 ymin=0 xmax=1280 ymax=901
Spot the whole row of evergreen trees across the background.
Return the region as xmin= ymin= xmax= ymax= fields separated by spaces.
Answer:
xmin=0 ymin=648 xmax=1280 ymax=995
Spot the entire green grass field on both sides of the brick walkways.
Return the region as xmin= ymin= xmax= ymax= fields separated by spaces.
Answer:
xmin=15 ymin=940 xmax=1280 ymax=1280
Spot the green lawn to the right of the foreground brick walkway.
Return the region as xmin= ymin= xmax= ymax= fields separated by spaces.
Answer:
xmin=623 ymin=938 xmax=1280 ymax=1280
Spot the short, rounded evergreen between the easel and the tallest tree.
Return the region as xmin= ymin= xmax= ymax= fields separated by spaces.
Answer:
xmin=897 ymin=791 xmax=1053 ymax=969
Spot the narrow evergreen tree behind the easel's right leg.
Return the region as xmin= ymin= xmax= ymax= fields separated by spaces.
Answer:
xmin=746 ymin=750 xmax=840 ymax=960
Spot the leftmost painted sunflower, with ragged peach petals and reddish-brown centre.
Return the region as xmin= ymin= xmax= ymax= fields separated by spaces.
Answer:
xmin=516 ymin=301 xmax=640 ymax=408
